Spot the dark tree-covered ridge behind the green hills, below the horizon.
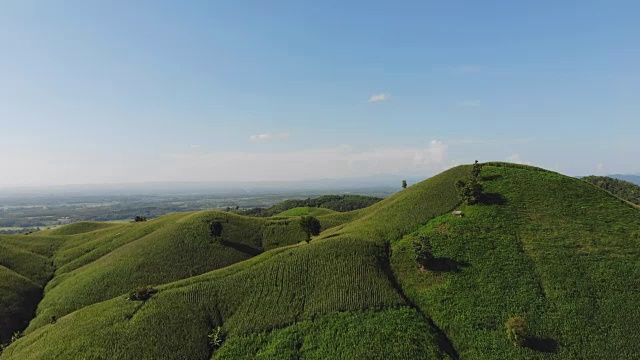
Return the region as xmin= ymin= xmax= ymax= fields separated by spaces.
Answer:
xmin=241 ymin=195 xmax=382 ymax=216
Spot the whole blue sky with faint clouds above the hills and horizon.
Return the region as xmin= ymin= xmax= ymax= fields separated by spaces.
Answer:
xmin=0 ymin=0 xmax=640 ymax=186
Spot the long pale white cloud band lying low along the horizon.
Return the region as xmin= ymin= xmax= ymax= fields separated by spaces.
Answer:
xmin=0 ymin=140 xmax=452 ymax=185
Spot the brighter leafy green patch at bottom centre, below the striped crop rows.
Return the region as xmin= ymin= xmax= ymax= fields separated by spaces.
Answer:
xmin=212 ymin=307 xmax=445 ymax=360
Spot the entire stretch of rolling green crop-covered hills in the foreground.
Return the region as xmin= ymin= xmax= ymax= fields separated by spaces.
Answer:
xmin=0 ymin=163 xmax=640 ymax=360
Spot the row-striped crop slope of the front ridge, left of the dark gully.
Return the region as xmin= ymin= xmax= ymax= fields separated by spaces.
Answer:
xmin=3 ymin=241 xmax=404 ymax=359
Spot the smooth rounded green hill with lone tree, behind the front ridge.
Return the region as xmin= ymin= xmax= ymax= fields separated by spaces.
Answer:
xmin=27 ymin=211 xmax=304 ymax=331
